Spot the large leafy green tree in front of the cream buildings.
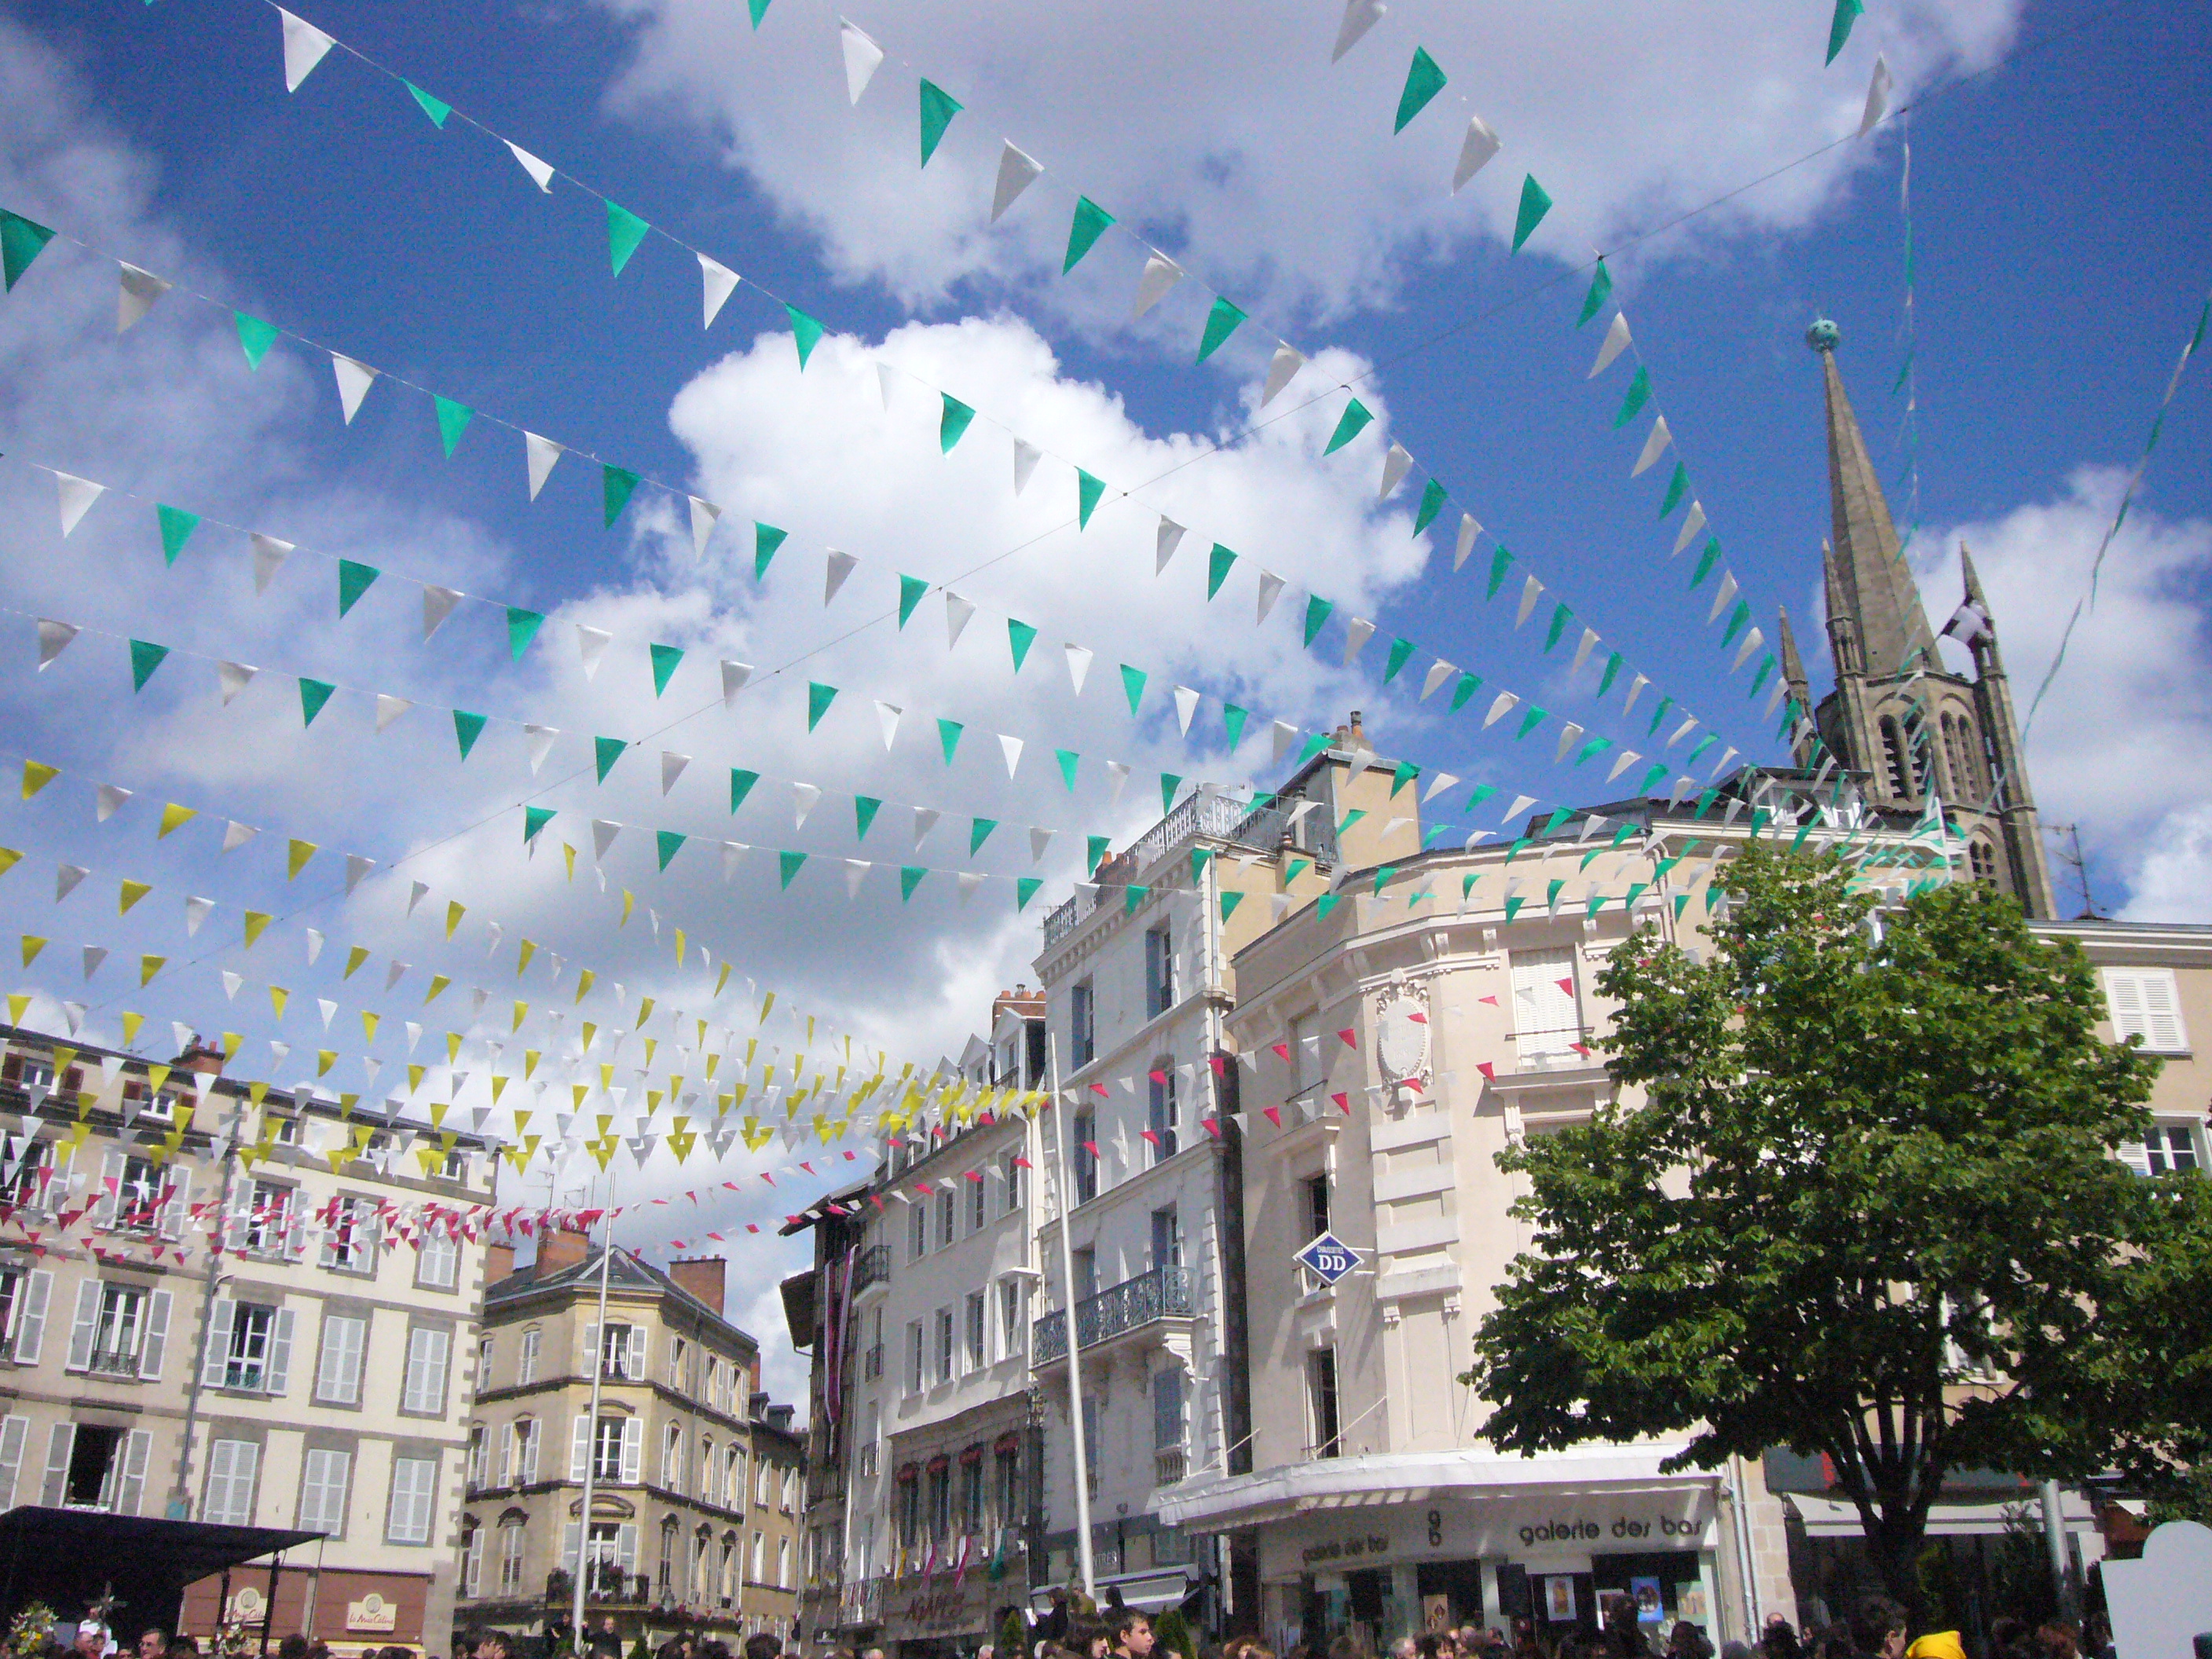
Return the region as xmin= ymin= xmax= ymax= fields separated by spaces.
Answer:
xmin=1464 ymin=843 xmax=2212 ymax=1608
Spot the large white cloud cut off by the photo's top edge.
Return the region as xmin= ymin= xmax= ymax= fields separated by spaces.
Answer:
xmin=602 ymin=0 xmax=2020 ymax=327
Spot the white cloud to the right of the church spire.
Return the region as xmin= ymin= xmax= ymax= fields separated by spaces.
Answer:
xmin=1911 ymin=467 xmax=2212 ymax=922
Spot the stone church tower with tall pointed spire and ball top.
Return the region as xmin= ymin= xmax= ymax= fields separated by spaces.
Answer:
xmin=1776 ymin=320 xmax=2057 ymax=916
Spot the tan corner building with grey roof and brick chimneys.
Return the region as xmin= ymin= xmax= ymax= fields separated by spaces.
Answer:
xmin=460 ymin=1232 xmax=805 ymax=1648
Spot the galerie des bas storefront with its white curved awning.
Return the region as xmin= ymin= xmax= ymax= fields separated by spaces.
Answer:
xmin=1163 ymin=1453 xmax=1721 ymax=1650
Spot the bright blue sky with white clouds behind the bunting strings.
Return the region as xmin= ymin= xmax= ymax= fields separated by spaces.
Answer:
xmin=0 ymin=0 xmax=2212 ymax=1371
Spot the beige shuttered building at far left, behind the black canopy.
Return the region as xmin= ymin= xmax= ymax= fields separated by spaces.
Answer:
xmin=0 ymin=1031 xmax=493 ymax=1654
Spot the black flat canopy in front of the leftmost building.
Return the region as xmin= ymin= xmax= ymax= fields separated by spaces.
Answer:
xmin=0 ymin=1504 xmax=320 ymax=1639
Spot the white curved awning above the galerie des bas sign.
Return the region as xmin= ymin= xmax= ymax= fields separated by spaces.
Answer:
xmin=1157 ymin=1445 xmax=1719 ymax=1533
